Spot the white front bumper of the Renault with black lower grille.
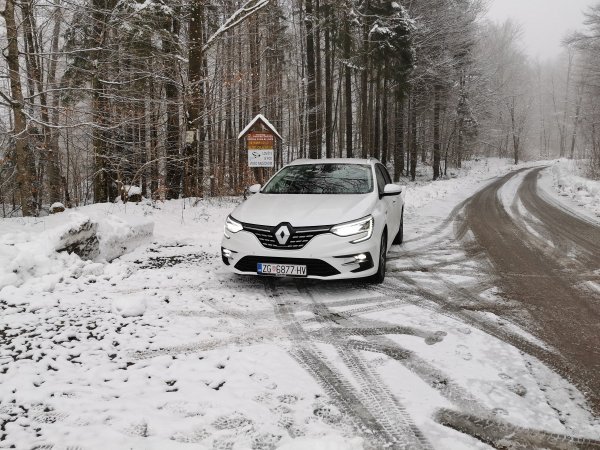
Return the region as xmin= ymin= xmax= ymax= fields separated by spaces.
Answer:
xmin=221 ymin=230 xmax=379 ymax=280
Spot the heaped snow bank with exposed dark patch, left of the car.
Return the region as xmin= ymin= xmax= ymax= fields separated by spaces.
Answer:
xmin=0 ymin=207 xmax=153 ymax=304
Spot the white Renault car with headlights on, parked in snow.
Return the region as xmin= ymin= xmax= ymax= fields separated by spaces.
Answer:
xmin=221 ymin=159 xmax=404 ymax=283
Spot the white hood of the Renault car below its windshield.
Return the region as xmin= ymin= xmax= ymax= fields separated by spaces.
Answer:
xmin=231 ymin=193 xmax=377 ymax=227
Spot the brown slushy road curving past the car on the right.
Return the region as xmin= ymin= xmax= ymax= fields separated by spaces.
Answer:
xmin=465 ymin=169 xmax=600 ymax=413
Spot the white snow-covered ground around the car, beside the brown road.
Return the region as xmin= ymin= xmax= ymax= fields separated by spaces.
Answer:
xmin=0 ymin=160 xmax=600 ymax=449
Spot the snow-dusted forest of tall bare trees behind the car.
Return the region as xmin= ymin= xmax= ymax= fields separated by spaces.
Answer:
xmin=0 ymin=0 xmax=600 ymax=217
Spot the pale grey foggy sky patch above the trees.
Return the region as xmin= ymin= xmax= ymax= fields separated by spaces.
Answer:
xmin=488 ymin=0 xmax=598 ymax=60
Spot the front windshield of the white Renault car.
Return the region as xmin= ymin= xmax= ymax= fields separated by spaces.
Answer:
xmin=262 ymin=164 xmax=373 ymax=195
